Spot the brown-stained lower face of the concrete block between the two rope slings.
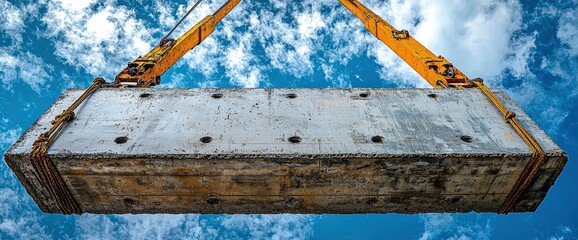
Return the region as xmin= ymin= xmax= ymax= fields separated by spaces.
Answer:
xmin=53 ymin=158 xmax=517 ymax=213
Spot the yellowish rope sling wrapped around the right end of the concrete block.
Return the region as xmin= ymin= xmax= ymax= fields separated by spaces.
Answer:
xmin=472 ymin=80 xmax=546 ymax=214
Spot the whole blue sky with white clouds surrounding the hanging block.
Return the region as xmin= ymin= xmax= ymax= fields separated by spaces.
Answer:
xmin=0 ymin=0 xmax=578 ymax=239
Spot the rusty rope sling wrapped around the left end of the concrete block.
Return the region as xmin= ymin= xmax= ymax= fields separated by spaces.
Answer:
xmin=30 ymin=78 xmax=114 ymax=214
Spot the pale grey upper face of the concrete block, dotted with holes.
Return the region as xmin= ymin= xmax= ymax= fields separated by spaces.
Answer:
xmin=8 ymin=88 xmax=564 ymax=158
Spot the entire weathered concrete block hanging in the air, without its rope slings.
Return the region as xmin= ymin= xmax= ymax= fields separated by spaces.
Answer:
xmin=5 ymin=89 xmax=567 ymax=213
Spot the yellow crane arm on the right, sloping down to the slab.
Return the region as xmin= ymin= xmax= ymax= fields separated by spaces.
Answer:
xmin=339 ymin=0 xmax=474 ymax=88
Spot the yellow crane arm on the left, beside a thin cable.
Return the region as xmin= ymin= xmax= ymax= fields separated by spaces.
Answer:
xmin=115 ymin=0 xmax=241 ymax=87
